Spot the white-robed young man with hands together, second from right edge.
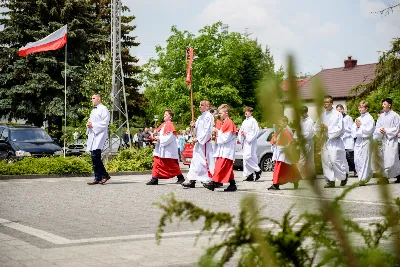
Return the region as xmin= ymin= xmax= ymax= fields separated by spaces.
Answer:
xmin=351 ymin=101 xmax=375 ymax=185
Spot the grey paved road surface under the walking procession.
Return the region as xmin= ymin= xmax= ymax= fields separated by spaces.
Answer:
xmin=0 ymin=172 xmax=400 ymax=266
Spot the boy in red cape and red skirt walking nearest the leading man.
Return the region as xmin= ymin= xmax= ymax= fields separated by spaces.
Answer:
xmin=147 ymin=109 xmax=185 ymax=185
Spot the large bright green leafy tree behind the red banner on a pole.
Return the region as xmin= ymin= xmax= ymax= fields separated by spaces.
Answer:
xmin=142 ymin=22 xmax=281 ymax=126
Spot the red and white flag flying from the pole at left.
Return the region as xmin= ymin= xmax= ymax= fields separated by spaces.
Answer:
xmin=18 ymin=25 xmax=67 ymax=57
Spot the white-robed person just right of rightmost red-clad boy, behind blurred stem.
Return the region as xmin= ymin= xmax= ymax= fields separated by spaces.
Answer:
xmin=297 ymin=106 xmax=315 ymax=179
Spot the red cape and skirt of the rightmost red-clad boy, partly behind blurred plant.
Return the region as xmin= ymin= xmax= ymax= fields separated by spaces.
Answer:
xmin=271 ymin=129 xmax=301 ymax=184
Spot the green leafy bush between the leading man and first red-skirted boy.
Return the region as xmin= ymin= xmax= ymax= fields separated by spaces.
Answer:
xmin=106 ymin=147 xmax=153 ymax=172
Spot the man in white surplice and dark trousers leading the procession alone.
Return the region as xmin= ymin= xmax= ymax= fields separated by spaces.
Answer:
xmin=86 ymin=93 xmax=111 ymax=185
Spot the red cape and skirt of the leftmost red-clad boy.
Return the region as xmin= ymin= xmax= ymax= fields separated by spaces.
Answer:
xmin=151 ymin=122 xmax=182 ymax=179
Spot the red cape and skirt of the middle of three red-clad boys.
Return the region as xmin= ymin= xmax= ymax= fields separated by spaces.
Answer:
xmin=212 ymin=118 xmax=237 ymax=183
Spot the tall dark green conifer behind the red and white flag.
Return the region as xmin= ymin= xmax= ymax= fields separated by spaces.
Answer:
xmin=0 ymin=0 xmax=142 ymax=131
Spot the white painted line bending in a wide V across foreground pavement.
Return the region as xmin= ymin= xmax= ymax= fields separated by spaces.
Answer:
xmin=0 ymin=217 xmax=384 ymax=245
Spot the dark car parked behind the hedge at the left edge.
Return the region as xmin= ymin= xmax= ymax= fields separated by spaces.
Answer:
xmin=0 ymin=125 xmax=63 ymax=162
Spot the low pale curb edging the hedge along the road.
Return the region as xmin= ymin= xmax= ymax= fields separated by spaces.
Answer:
xmin=0 ymin=169 xmax=189 ymax=180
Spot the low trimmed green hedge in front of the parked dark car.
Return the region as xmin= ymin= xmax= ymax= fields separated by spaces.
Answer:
xmin=0 ymin=157 xmax=92 ymax=175
